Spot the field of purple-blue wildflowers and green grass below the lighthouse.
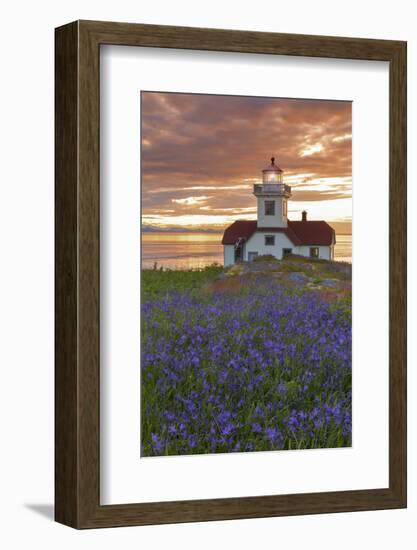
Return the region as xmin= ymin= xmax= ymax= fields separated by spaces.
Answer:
xmin=141 ymin=264 xmax=352 ymax=456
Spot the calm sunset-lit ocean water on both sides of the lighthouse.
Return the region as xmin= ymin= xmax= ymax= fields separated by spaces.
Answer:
xmin=142 ymin=232 xmax=352 ymax=269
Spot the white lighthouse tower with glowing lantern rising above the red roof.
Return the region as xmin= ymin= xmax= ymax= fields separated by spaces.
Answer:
xmin=253 ymin=157 xmax=291 ymax=228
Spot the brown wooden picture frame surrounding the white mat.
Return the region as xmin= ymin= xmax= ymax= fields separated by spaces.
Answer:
xmin=55 ymin=21 xmax=406 ymax=528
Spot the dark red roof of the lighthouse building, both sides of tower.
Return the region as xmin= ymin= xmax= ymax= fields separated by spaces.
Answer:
xmin=222 ymin=220 xmax=336 ymax=246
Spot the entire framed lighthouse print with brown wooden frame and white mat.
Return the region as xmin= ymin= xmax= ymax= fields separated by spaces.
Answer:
xmin=55 ymin=21 xmax=406 ymax=528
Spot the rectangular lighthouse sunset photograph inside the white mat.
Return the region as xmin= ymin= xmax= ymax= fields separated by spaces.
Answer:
xmin=138 ymin=91 xmax=352 ymax=457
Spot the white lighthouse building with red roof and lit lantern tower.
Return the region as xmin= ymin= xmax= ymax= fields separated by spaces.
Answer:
xmin=222 ymin=157 xmax=336 ymax=266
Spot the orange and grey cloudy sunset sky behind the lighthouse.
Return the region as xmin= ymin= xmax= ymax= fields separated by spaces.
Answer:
xmin=141 ymin=92 xmax=352 ymax=233
